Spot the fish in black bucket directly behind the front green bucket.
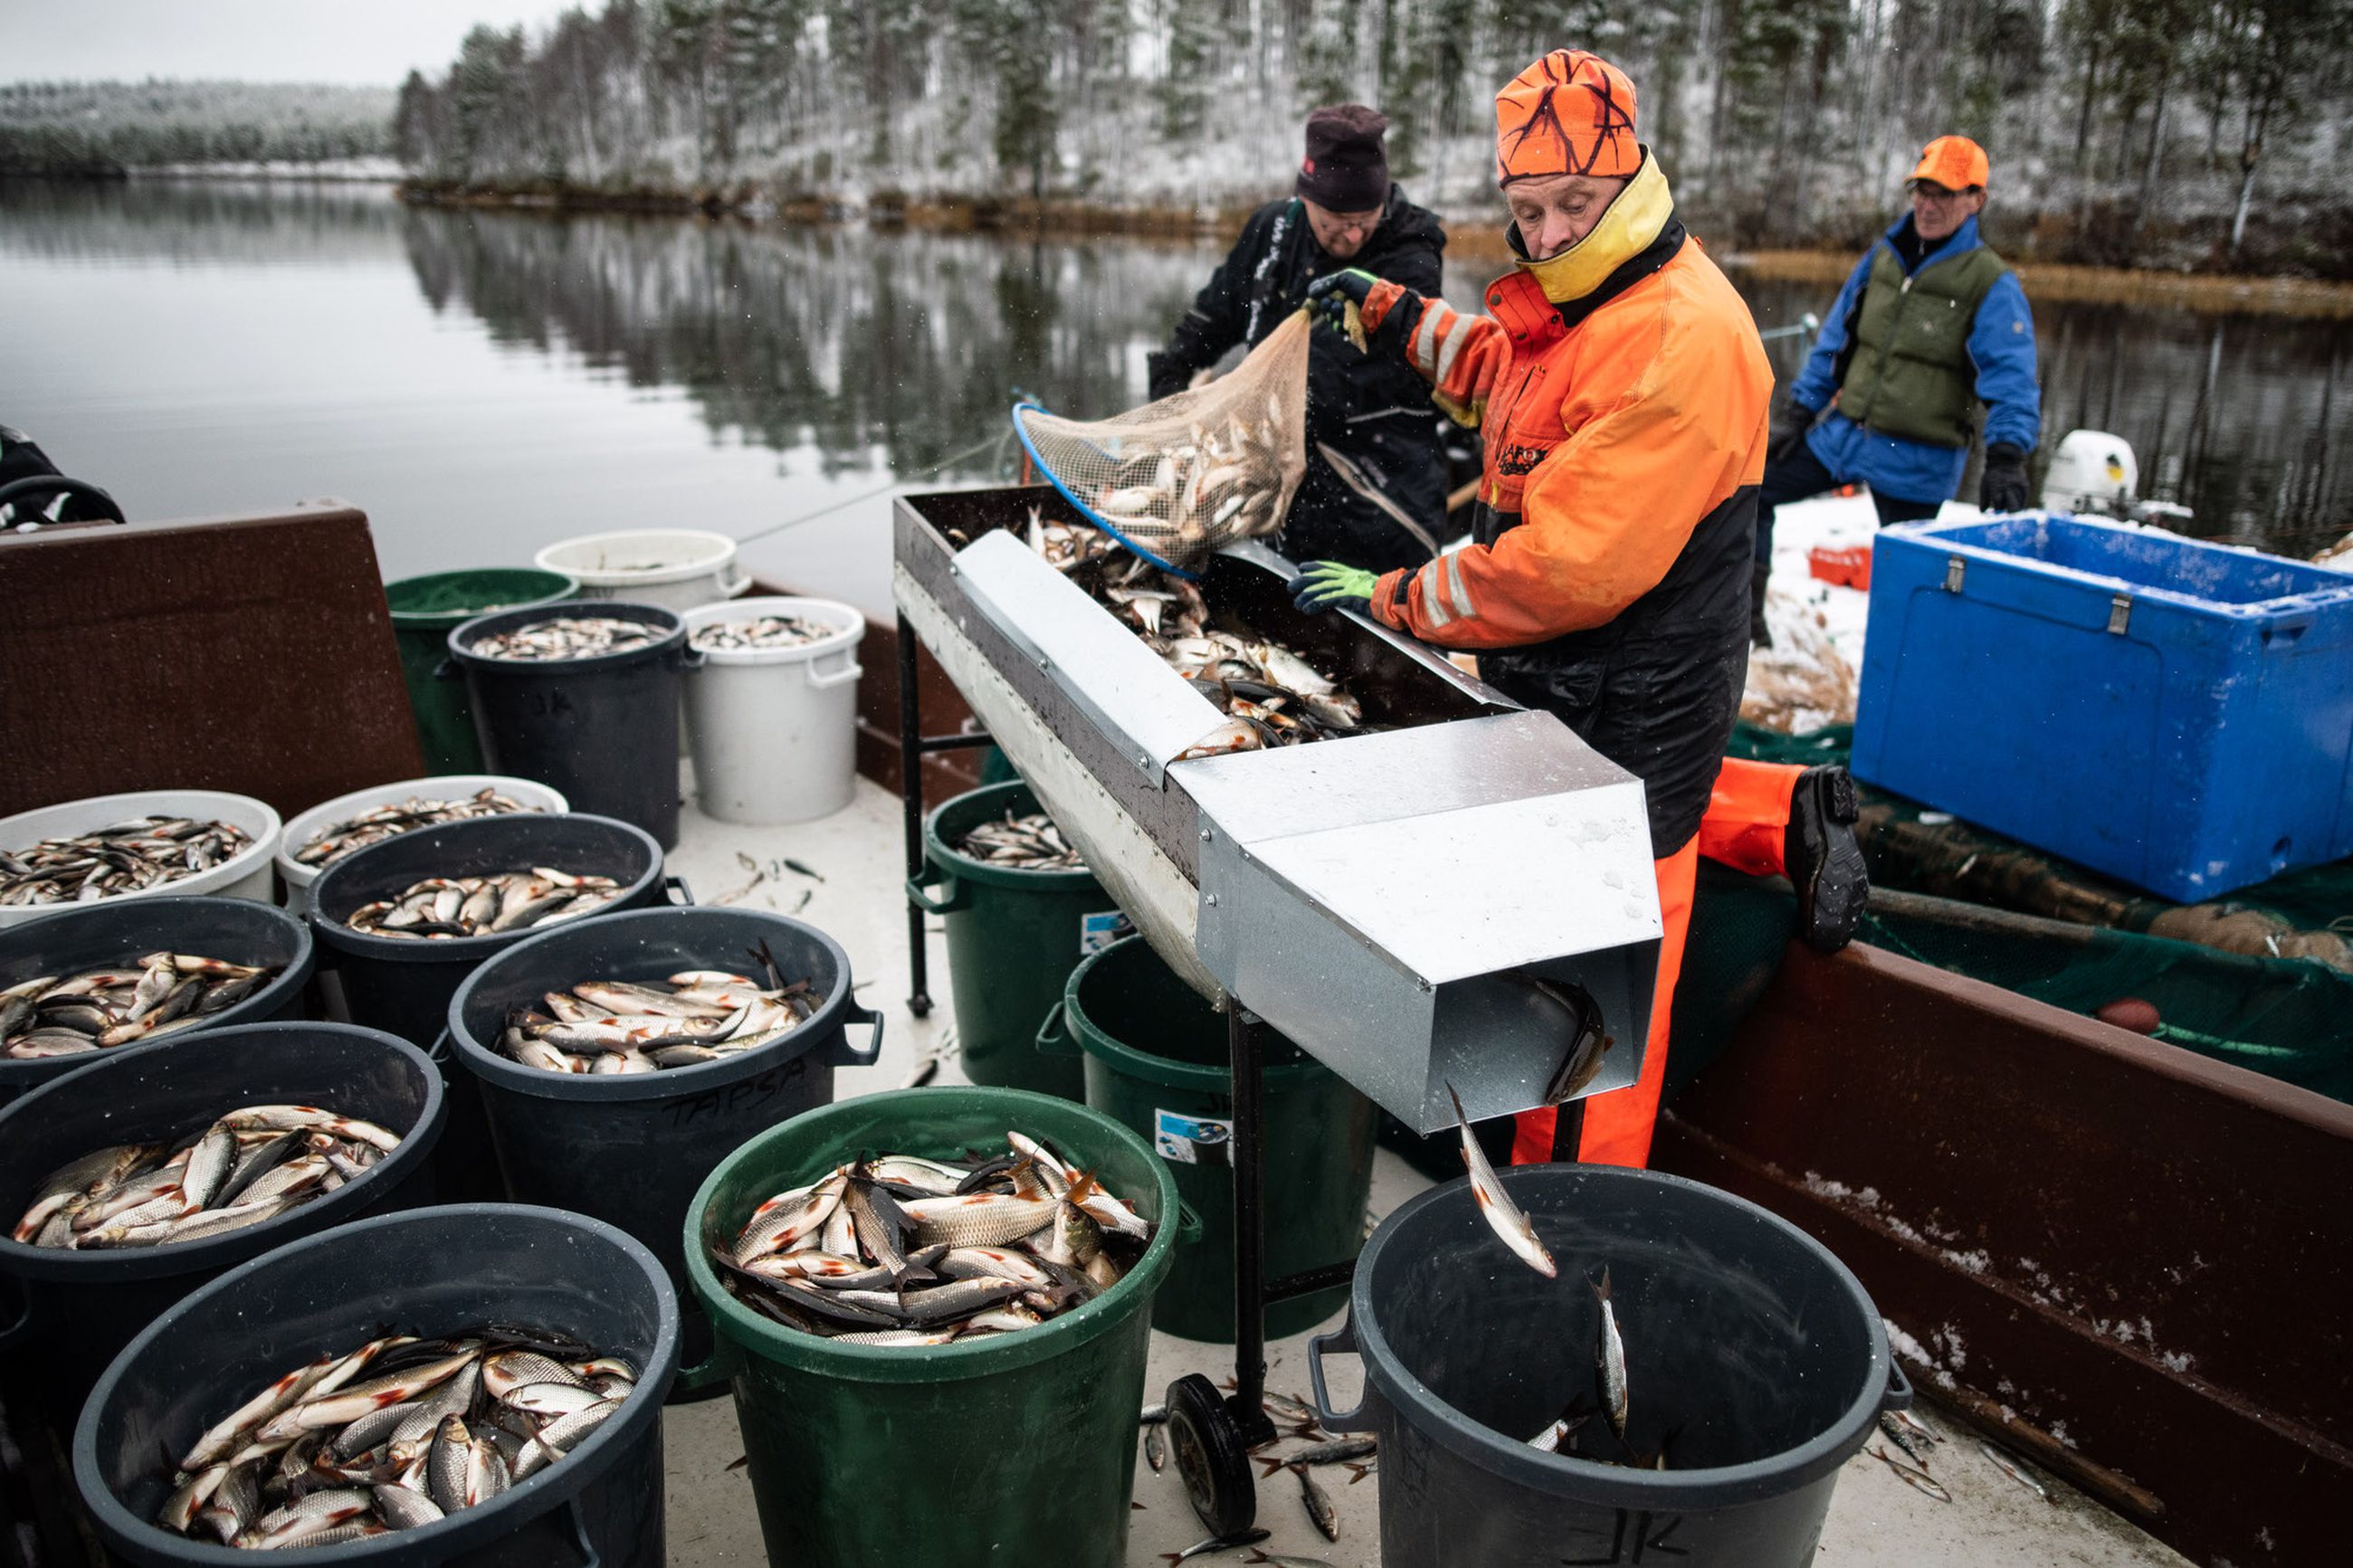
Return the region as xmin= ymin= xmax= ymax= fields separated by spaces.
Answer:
xmin=499 ymin=955 xmax=826 ymax=1074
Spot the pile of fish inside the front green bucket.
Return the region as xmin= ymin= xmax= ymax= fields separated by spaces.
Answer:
xmin=710 ymin=1133 xmax=1153 ymax=1345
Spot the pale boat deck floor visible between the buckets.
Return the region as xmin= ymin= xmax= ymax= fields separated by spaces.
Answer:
xmin=644 ymin=778 xmax=2188 ymax=1568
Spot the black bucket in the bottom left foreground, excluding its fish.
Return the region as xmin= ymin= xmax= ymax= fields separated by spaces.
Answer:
xmin=73 ymin=1203 xmax=678 ymax=1568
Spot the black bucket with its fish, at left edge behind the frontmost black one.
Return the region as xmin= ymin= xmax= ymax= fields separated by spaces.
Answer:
xmin=0 ymin=1022 xmax=443 ymax=1418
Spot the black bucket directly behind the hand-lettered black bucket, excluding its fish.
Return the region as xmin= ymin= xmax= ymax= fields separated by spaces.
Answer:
xmin=310 ymin=811 xmax=662 ymax=1203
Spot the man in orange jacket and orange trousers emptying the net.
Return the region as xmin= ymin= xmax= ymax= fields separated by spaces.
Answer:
xmin=1291 ymin=50 xmax=1863 ymax=1166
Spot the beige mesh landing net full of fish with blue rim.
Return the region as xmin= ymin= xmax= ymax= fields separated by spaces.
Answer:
xmin=1015 ymin=310 xmax=1310 ymax=574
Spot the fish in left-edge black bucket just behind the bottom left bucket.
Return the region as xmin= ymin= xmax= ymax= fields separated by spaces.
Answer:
xmin=14 ymin=1105 xmax=400 ymax=1250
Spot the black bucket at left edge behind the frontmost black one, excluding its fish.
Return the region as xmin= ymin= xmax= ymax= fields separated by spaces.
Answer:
xmin=0 ymin=1022 xmax=443 ymax=1420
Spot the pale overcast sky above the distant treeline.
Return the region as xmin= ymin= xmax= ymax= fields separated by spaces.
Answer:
xmin=0 ymin=0 xmax=588 ymax=87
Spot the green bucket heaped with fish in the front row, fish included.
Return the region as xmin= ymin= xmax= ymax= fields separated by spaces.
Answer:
xmin=682 ymin=1088 xmax=1181 ymax=1568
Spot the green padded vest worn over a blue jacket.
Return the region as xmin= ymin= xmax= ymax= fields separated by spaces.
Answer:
xmin=1838 ymin=244 xmax=2009 ymax=447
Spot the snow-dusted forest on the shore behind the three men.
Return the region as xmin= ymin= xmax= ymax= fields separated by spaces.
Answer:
xmin=395 ymin=0 xmax=2353 ymax=275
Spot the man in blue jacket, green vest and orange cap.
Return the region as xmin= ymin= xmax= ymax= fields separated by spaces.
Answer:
xmin=1748 ymin=137 xmax=2043 ymax=647
